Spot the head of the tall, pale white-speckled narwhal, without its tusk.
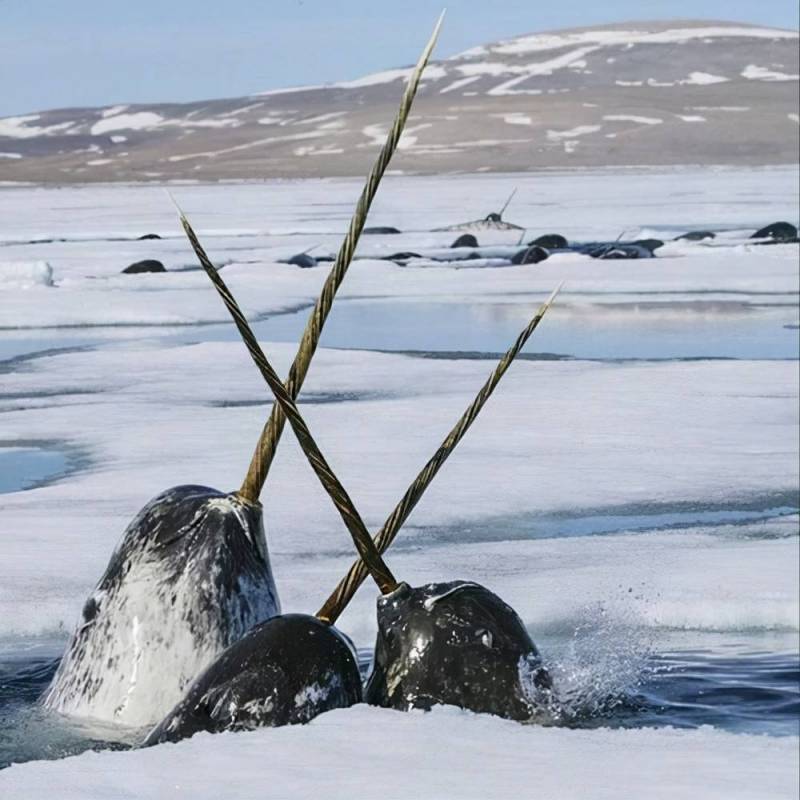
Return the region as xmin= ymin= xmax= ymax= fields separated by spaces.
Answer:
xmin=43 ymin=486 xmax=280 ymax=726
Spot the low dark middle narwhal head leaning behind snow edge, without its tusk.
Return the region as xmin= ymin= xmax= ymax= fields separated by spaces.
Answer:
xmin=144 ymin=614 xmax=362 ymax=746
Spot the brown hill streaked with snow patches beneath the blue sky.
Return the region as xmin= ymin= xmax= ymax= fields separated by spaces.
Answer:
xmin=0 ymin=21 xmax=800 ymax=182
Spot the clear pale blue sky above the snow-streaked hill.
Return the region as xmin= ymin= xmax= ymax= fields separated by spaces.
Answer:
xmin=0 ymin=0 xmax=798 ymax=116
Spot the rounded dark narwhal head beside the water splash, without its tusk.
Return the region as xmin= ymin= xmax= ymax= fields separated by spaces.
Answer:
xmin=365 ymin=581 xmax=550 ymax=721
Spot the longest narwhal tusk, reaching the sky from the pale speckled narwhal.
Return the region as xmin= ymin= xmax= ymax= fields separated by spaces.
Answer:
xmin=239 ymin=11 xmax=445 ymax=502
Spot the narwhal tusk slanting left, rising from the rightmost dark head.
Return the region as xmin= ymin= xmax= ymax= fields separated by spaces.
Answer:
xmin=170 ymin=196 xmax=398 ymax=594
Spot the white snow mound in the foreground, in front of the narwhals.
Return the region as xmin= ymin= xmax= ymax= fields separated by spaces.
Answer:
xmin=0 ymin=705 xmax=798 ymax=800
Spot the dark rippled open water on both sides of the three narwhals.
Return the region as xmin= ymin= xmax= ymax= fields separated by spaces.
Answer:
xmin=0 ymin=645 xmax=800 ymax=769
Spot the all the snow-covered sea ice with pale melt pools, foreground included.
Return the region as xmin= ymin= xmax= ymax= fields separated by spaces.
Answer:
xmin=0 ymin=167 xmax=800 ymax=800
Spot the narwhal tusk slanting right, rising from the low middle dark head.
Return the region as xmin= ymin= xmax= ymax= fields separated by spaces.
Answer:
xmin=317 ymin=282 xmax=563 ymax=624
